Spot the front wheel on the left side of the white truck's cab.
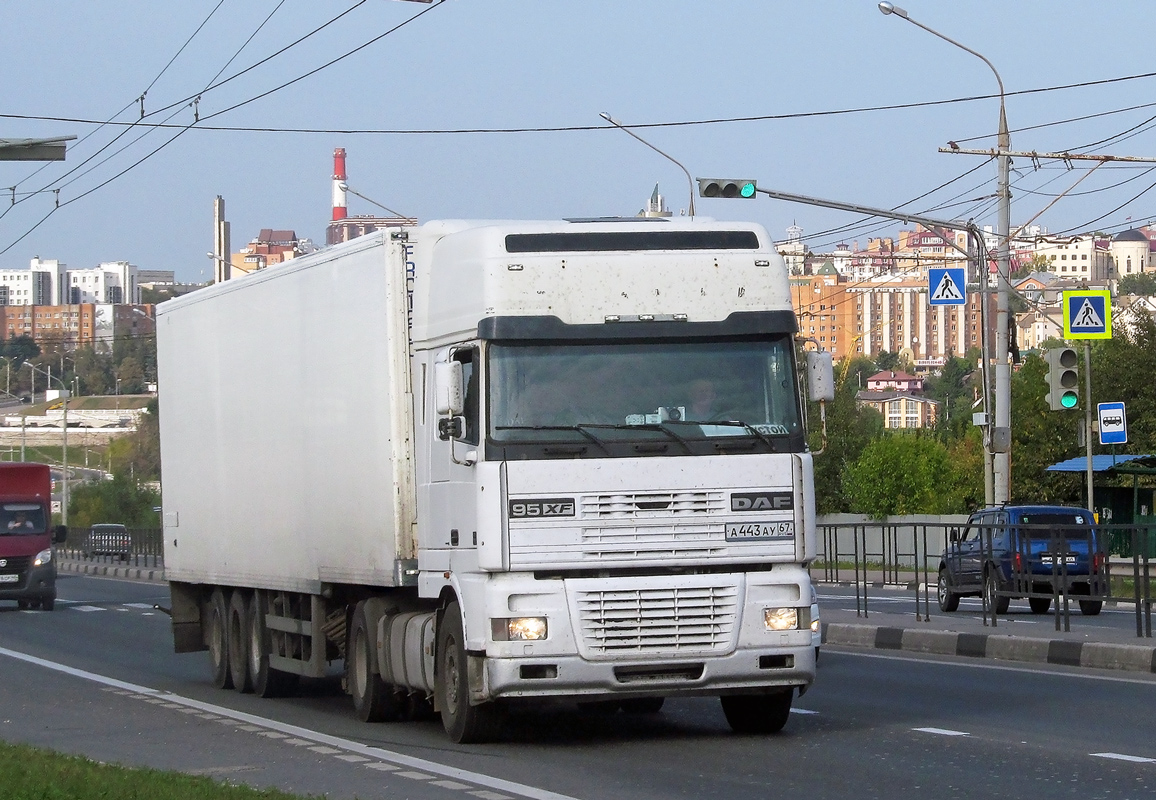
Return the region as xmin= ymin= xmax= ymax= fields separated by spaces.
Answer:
xmin=435 ymin=601 xmax=501 ymax=745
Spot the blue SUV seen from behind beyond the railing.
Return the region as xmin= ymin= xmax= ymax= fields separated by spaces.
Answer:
xmin=938 ymin=505 xmax=1107 ymax=615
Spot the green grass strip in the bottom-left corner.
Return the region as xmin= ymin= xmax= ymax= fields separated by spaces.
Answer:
xmin=0 ymin=741 xmax=319 ymax=800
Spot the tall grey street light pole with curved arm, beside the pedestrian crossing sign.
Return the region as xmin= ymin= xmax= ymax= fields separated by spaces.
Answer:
xmin=879 ymin=2 xmax=1012 ymax=503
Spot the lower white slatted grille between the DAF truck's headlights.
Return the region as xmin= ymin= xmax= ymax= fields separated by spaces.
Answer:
xmin=577 ymin=586 xmax=739 ymax=657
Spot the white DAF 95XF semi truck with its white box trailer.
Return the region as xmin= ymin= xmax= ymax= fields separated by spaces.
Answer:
xmin=157 ymin=217 xmax=831 ymax=742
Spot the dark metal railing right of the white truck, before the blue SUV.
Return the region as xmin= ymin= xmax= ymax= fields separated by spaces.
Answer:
xmin=810 ymin=523 xmax=1156 ymax=638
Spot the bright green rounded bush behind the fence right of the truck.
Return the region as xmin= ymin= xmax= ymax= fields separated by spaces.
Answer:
xmin=843 ymin=432 xmax=964 ymax=519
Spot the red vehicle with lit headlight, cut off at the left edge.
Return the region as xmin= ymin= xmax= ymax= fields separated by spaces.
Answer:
xmin=0 ymin=464 xmax=68 ymax=612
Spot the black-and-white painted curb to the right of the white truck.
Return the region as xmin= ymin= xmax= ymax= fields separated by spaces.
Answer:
xmin=823 ymin=622 xmax=1156 ymax=674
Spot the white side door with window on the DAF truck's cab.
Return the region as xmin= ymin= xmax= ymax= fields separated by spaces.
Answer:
xmin=430 ymin=347 xmax=481 ymax=559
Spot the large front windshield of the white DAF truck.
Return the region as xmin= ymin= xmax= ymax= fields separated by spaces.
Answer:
xmin=489 ymin=335 xmax=802 ymax=454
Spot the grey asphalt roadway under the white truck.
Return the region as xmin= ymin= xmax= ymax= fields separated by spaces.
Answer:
xmin=0 ymin=573 xmax=1156 ymax=800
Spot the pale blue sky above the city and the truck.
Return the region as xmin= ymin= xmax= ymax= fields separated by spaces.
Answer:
xmin=0 ymin=0 xmax=1156 ymax=282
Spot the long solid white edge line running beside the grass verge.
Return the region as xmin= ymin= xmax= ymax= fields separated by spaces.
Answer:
xmin=0 ymin=647 xmax=577 ymax=800
